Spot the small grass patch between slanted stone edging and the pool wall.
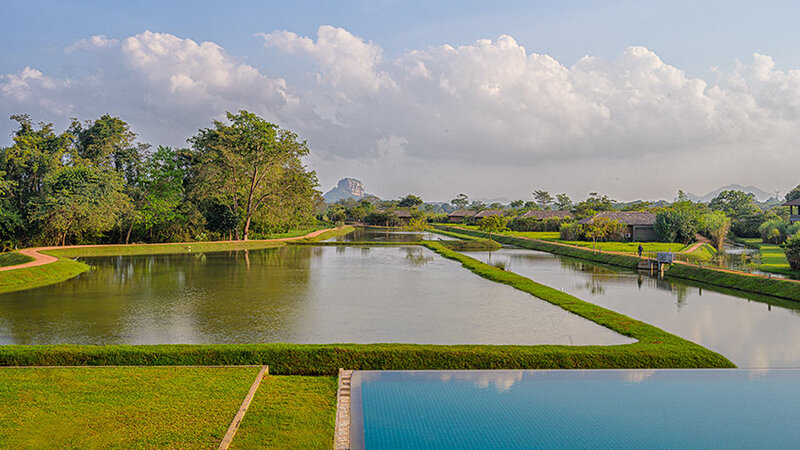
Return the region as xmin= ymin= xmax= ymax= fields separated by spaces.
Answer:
xmin=231 ymin=376 xmax=337 ymax=449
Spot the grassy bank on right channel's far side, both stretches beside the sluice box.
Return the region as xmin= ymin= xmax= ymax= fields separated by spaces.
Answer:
xmin=440 ymin=225 xmax=800 ymax=301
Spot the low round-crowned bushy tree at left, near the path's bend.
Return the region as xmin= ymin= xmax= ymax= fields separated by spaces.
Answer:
xmin=32 ymin=166 xmax=129 ymax=245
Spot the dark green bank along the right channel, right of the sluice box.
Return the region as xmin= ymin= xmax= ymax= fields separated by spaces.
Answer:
xmin=666 ymin=264 xmax=800 ymax=301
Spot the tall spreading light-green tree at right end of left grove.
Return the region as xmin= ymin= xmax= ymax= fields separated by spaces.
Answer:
xmin=189 ymin=110 xmax=320 ymax=240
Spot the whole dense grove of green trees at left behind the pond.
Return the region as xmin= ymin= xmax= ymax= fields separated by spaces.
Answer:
xmin=0 ymin=111 xmax=322 ymax=249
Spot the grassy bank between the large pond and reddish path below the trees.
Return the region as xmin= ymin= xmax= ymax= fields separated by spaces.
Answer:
xmin=0 ymin=227 xmax=354 ymax=294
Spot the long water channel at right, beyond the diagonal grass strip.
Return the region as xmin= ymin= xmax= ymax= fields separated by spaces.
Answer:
xmin=467 ymin=249 xmax=800 ymax=368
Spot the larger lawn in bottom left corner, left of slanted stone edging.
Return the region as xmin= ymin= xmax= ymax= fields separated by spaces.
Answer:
xmin=0 ymin=367 xmax=259 ymax=448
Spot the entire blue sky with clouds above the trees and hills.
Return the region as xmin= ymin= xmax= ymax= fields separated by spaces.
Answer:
xmin=0 ymin=0 xmax=800 ymax=201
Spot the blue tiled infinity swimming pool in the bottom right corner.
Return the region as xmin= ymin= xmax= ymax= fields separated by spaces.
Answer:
xmin=350 ymin=369 xmax=800 ymax=449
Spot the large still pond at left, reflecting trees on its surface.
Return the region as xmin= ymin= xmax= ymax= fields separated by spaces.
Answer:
xmin=0 ymin=246 xmax=632 ymax=345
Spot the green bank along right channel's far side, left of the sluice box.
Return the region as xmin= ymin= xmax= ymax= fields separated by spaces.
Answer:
xmin=437 ymin=226 xmax=639 ymax=269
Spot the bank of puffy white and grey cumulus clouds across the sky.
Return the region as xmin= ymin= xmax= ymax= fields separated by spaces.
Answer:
xmin=0 ymin=26 xmax=800 ymax=199
